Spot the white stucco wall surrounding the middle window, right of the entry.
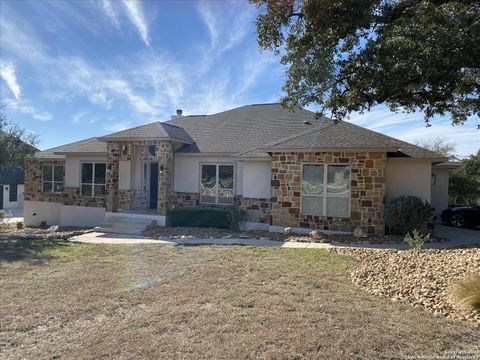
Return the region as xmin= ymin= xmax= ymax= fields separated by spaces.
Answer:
xmin=173 ymin=154 xmax=243 ymax=195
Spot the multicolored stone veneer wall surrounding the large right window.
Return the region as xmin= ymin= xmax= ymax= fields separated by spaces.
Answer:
xmin=271 ymin=152 xmax=387 ymax=235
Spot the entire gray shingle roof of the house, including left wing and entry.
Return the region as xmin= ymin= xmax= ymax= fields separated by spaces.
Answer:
xmin=36 ymin=104 xmax=446 ymax=161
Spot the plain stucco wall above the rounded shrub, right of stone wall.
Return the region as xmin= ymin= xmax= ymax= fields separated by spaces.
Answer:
xmin=386 ymin=158 xmax=432 ymax=202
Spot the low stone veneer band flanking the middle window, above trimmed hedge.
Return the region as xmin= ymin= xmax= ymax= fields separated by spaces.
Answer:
xmin=171 ymin=192 xmax=271 ymax=224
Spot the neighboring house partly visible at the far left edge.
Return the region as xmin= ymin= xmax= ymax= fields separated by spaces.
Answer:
xmin=0 ymin=170 xmax=24 ymax=210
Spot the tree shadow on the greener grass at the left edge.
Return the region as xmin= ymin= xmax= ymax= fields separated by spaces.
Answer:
xmin=0 ymin=239 xmax=76 ymax=263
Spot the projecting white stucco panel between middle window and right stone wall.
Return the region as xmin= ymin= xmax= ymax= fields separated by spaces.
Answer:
xmin=243 ymin=161 xmax=272 ymax=199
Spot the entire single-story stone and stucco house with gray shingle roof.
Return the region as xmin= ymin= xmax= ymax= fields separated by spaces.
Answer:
xmin=25 ymin=104 xmax=447 ymax=234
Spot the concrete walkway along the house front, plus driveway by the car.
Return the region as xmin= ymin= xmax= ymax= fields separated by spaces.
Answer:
xmin=70 ymin=225 xmax=480 ymax=250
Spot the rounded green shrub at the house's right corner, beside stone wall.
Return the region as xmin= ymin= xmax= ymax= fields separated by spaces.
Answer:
xmin=385 ymin=196 xmax=435 ymax=235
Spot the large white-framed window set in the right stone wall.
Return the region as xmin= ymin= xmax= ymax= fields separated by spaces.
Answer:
xmin=302 ymin=165 xmax=350 ymax=217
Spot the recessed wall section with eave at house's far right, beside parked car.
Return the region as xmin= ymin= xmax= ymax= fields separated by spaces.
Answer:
xmin=432 ymin=161 xmax=460 ymax=219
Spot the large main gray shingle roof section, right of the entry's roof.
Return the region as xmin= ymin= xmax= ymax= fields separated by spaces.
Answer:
xmin=168 ymin=104 xmax=442 ymax=158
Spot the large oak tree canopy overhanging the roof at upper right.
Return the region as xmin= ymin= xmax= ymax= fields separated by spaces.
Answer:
xmin=250 ymin=0 xmax=480 ymax=125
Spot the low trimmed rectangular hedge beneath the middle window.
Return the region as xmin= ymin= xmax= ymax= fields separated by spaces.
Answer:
xmin=167 ymin=208 xmax=245 ymax=231
